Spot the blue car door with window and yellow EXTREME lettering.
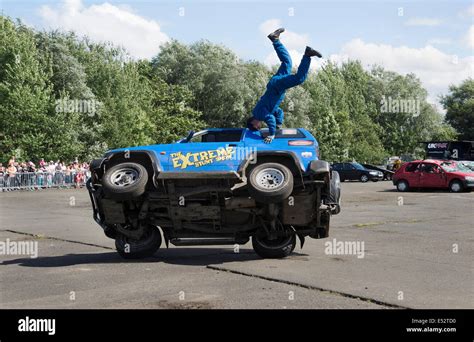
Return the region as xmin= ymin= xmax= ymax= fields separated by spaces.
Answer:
xmin=169 ymin=130 xmax=243 ymax=172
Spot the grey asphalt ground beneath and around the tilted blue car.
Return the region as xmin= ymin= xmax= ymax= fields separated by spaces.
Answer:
xmin=0 ymin=182 xmax=474 ymax=309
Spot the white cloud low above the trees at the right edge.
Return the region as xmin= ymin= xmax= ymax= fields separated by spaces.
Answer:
xmin=330 ymin=39 xmax=474 ymax=103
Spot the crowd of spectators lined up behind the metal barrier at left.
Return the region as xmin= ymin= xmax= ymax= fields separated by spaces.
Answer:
xmin=0 ymin=157 xmax=90 ymax=191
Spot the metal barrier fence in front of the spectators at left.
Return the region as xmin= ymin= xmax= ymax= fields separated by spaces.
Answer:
xmin=0 ymin=171 xmax=90 ymax=191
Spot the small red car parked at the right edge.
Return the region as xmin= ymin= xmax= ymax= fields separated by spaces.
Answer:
xmin=393 ymin=159 xmax=474 ymax=192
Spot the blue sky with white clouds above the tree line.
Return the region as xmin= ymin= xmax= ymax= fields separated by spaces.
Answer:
xmin=0 ymin=0 xmax=474 ymax=102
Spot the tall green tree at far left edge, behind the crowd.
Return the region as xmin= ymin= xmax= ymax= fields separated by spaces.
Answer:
xmin=0 ymin=17 xmax=62 ymax=160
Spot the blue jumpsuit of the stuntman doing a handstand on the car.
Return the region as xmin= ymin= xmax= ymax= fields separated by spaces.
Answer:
xmin=252 ymin=40 xmax=311 ymax=135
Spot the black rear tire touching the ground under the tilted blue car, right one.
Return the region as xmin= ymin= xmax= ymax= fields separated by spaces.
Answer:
xmin=252 ymin=235 xmax=296 ymax=259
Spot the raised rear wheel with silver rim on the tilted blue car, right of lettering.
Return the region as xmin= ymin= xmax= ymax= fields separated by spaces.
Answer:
xmin=248 ymin=163 xmax=293 ymax=203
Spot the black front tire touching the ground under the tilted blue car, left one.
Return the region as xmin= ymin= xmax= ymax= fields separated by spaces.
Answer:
xmin=115 ymin=226 xmax=162 ymax=259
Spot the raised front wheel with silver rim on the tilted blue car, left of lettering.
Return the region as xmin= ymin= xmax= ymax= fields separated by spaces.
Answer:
xmin=102 ymin=163 xmax=148 ymax=200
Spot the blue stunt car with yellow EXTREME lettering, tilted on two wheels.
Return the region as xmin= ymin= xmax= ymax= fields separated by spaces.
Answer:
xmin=87 ymin=128 xmax=340 ymax=258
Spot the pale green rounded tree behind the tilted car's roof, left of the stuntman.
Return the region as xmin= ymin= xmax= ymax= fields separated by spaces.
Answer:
xmin=152 ymin=41 xmax=262 ymax=127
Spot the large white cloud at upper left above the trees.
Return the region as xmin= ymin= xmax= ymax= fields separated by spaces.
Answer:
xmin=39 ymin=0 xmax=169 ymax=58
